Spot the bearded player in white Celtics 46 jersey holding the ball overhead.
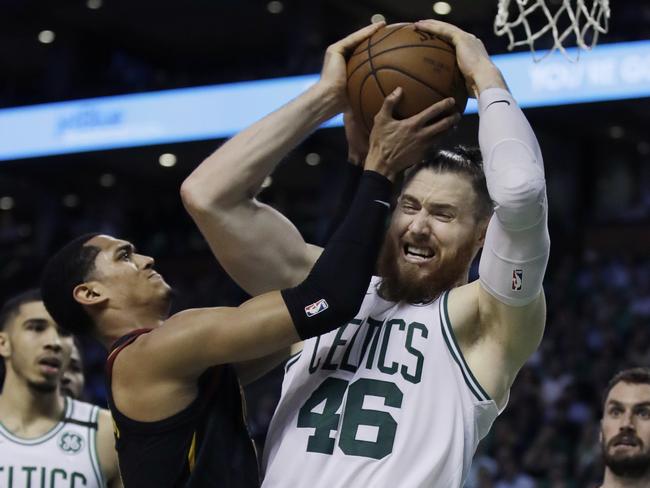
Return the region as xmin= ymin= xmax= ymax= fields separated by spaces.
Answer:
xmin=184 ymin=20 xmax=549 ymax=488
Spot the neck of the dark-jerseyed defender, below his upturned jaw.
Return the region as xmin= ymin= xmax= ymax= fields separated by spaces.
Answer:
xmin=96 ymin=308 xmax=167 ymax=349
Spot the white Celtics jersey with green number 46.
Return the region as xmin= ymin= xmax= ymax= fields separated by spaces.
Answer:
xmin=262 ymin=278 xmax=499 ymax=488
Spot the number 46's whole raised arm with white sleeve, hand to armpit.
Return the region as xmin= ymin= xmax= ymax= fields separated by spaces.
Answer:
xmin=418 ymin=20 xmax=550 ymax=401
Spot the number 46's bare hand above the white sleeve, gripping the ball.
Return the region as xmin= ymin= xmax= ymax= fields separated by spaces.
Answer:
xmin=415 ymin=19 xmax=508 ymax=98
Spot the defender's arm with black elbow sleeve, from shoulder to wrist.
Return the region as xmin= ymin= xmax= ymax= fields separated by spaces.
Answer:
xmin=112 ymin=165 xmax=393 ymax=420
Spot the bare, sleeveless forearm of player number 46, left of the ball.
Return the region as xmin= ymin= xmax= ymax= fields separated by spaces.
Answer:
xmin=181 ymin=83 xmax=340 ymax=210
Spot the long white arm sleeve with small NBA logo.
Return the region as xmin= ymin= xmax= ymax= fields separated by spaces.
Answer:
xmin=478 ymin=88 xmax=550 ymax=306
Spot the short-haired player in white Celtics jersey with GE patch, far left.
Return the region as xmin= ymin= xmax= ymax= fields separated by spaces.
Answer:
xmin=0 ymin=291 xmax=122 ymax=488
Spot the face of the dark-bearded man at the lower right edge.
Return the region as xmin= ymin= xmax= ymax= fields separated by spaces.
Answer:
xmin=601 ymin=381 xmax=650 ymax=478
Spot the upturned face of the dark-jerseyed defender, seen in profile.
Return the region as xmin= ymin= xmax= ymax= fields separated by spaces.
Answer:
xmin=86 ymin=235 xmax=171 ymax=308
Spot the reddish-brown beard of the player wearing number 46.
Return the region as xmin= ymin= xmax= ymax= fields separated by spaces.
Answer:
xmin=378 ymin=234 xmax=474 ymax=303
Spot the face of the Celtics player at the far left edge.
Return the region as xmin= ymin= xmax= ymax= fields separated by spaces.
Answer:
xmin=0 ymin=301 xmax=70 ymax=392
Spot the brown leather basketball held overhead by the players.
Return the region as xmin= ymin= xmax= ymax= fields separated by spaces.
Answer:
xmin=347 ymin=23 xmax=467 ymax=131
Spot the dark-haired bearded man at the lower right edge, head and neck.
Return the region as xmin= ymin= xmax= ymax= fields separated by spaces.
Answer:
xmin=600 ymin=368 xmax=650 ymax=488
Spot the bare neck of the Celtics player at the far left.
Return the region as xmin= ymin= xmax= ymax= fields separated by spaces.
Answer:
xmin=0 ymin=367 xmax=65 ymax=431
